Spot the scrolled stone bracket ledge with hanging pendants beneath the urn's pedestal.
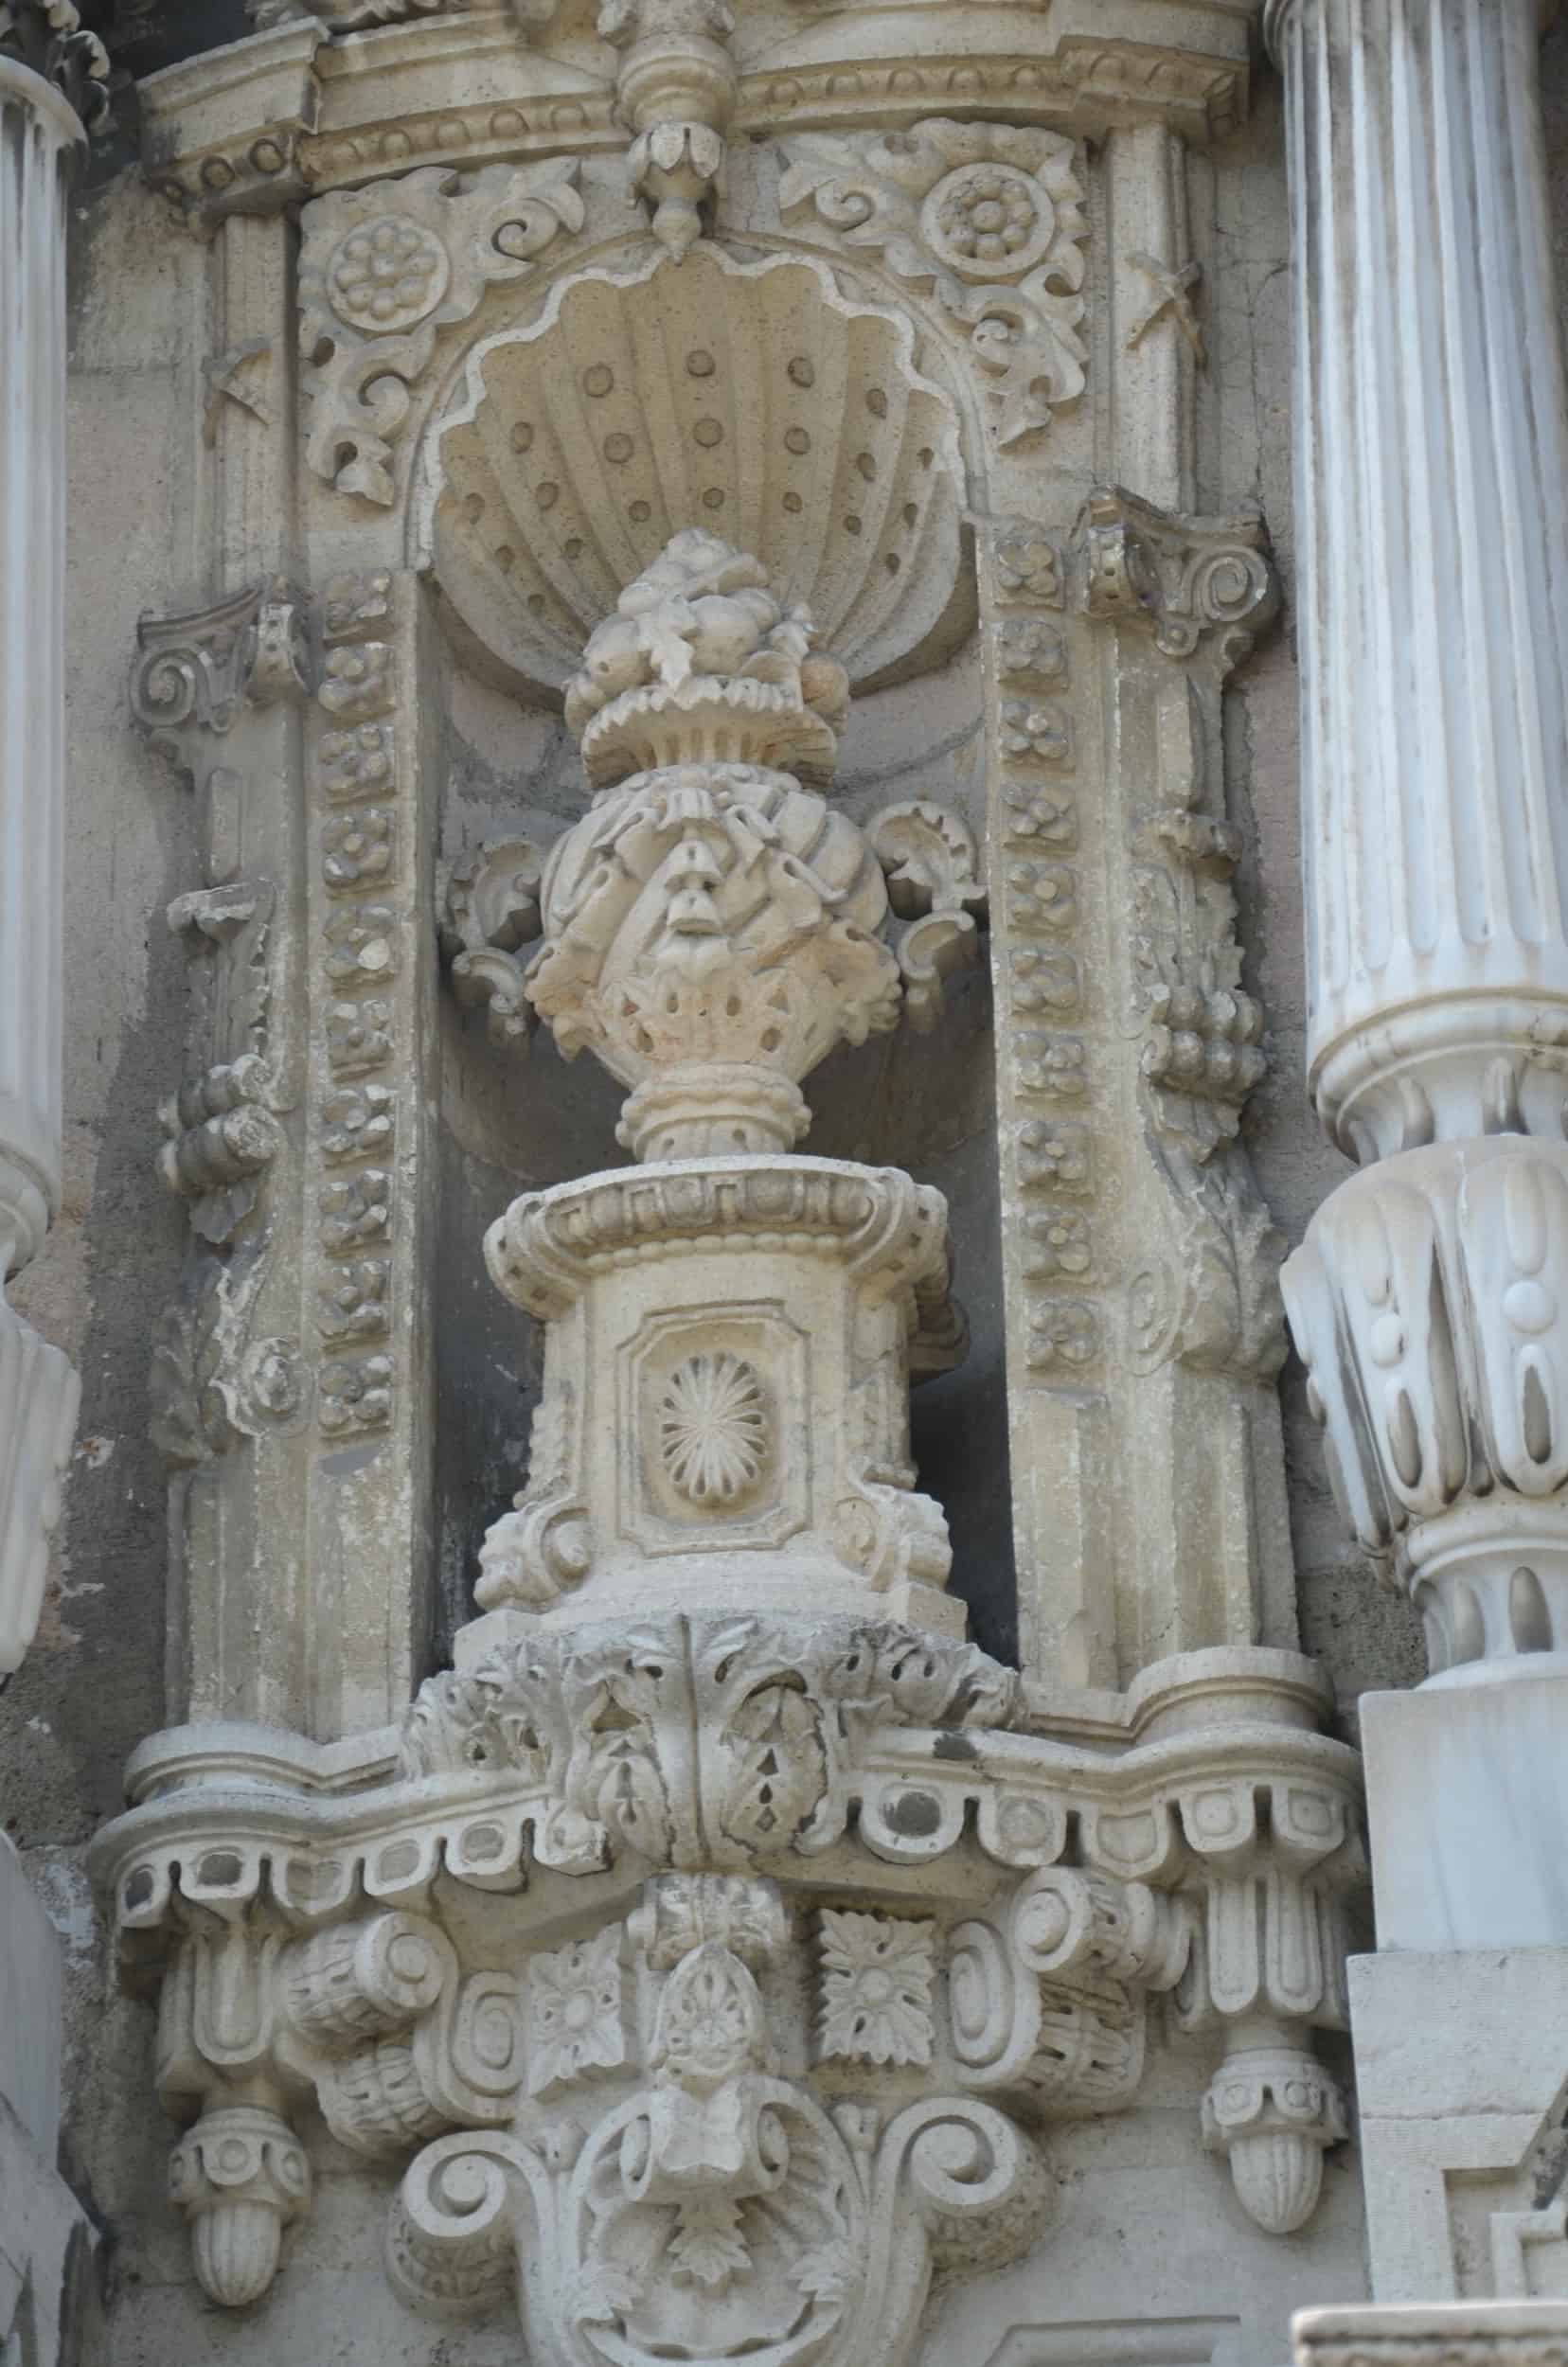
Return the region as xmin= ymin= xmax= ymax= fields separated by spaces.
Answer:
xmin=95 ymin=1612 xmax=1362 ymax=2339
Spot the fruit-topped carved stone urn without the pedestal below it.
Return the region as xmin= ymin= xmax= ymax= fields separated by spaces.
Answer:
xmin=528 ymin=528 xmax=898 ymax=1160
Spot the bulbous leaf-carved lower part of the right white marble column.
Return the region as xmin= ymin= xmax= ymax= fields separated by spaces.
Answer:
xmin=1281 ymin=1134 xmax=1568 ymax=1674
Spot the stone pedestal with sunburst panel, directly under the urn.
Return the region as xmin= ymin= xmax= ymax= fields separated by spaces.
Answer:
xmin=478 ymin=1158 xmax=964 ymax=1636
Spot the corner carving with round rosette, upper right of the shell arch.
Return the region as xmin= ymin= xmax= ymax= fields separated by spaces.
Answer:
xmin=779 ymin=116 xmax=1090 ymax=448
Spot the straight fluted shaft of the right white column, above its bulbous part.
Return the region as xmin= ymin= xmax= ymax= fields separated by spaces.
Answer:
xmin=1270 ymin=0 xmax=1568 ymax=1163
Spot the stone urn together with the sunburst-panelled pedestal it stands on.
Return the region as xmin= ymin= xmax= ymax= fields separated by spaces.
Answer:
xmin=478 ymin=528 xmax=969 ymax=1633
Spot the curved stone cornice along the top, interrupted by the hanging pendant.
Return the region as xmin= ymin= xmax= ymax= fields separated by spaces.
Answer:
xmin=140 ymin=0 xmax=1251 ymax=225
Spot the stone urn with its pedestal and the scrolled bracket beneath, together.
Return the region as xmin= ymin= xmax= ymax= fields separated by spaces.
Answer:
xmin=98 ymin=530 xmax=1362 ymax=2367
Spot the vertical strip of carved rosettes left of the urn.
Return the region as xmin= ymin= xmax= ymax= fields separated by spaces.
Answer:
xmin=306 ymin=573 xmax=436 ymax=1728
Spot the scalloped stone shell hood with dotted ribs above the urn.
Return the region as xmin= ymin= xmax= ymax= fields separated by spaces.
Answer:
xmin=417 ymin=246 xmax=973 ymax=694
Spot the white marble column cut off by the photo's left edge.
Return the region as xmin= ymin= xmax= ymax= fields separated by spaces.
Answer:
xmin=0 ymin=52 xmax=83 ymax=1671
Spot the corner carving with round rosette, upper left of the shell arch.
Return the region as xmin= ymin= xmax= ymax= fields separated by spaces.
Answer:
xmin=298 ymin=156 xmax=582 ymax=507
